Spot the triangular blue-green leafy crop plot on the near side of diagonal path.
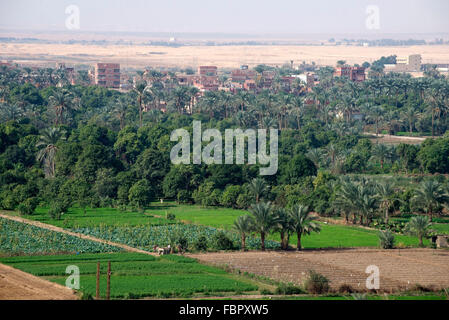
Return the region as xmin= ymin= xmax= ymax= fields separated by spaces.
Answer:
xmin=0 ymin=218 xmax=122 ymax=255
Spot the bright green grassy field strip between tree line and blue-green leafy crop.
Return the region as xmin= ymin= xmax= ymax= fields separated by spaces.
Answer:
xmin=1 ymin=203 xmax=432 ymax=249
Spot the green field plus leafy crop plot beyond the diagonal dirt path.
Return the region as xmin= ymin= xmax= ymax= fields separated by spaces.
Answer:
xmin=0 ymin=203 xmax=438 ymax=250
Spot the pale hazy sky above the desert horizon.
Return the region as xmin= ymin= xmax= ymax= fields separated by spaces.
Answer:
xmin=0 ymin=0 xmax=449 ymax=34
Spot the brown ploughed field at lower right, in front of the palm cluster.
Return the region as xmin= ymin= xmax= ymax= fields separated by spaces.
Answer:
xmin=189 ymin=249 xmax=449 ymax=292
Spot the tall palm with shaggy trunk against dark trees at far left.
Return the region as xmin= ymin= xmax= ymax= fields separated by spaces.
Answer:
xmin=36 ymin=128 xmax=65 ymax=178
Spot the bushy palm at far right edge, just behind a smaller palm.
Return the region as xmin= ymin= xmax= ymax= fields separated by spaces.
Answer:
xmin=412 ymin=180 xmax=449 ymax=222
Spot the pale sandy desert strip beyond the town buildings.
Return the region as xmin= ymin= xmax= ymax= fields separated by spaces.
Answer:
xmin=0 ymin=43 xmax=449 ymax=68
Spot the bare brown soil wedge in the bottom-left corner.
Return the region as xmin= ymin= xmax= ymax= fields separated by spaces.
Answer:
xmin=0 ymin=263 xmax=78 ymax=300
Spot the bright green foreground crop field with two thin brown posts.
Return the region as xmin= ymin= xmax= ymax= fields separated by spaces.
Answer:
xmin=0 ymin=253 xmax=258 ymax=298
